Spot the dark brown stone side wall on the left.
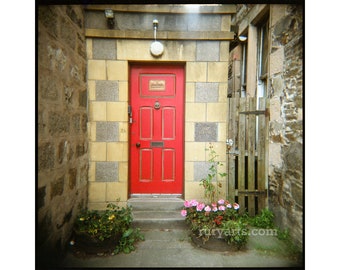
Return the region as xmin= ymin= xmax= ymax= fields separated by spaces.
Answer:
xmin=36 ymin=6 xmax=88 ymax=263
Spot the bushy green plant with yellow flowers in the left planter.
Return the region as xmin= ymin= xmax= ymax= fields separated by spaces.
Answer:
xmin=74 ymin=203 xmax=144 ymax=253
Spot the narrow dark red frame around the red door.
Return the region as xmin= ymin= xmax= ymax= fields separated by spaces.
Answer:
xmin=127 ymin=61 xmax=186 ymax=199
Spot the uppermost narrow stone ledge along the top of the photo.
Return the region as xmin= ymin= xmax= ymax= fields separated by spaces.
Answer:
xmin=86 ymin=4 xmax=236 ymax=14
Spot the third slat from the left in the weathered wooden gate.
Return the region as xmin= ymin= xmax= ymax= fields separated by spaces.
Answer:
xmin=247 ymin=98 xmax=256 ymax=216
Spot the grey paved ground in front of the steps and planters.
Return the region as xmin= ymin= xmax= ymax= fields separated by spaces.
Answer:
xmin=62 ymin=228 xmax=301 ymax=268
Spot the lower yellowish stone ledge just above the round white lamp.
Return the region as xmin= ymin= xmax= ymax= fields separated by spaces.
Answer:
xmin=85 ymin=29 xmax=234 ymax=41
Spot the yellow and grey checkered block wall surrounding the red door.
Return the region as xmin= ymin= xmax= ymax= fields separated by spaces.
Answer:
xmin=86 ymin=5 xmax=234 ymax=209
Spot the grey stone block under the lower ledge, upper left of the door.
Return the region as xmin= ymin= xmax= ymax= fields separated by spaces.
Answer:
xmin=92 ymin=38 xmax=117 ymax=60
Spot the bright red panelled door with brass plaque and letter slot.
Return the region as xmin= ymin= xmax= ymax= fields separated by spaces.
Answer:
xmin=129 ymin=65 xmax=184 ymax=194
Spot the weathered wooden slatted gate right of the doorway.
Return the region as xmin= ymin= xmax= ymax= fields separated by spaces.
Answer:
xmin=227 ymin=97 xmax=269 ymax=216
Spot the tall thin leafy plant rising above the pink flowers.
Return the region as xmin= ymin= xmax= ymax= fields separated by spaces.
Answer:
xmin=200 ymin=143 xmax=227 ymax=202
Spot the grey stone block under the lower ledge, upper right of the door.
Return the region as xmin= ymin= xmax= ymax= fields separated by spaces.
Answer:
xmin=196 ymin=41 xmax=220 ymax=62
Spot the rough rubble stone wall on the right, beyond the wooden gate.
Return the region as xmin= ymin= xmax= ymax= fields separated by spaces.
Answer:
xmin=232 ymin=5 xmax=304 ymax=249
